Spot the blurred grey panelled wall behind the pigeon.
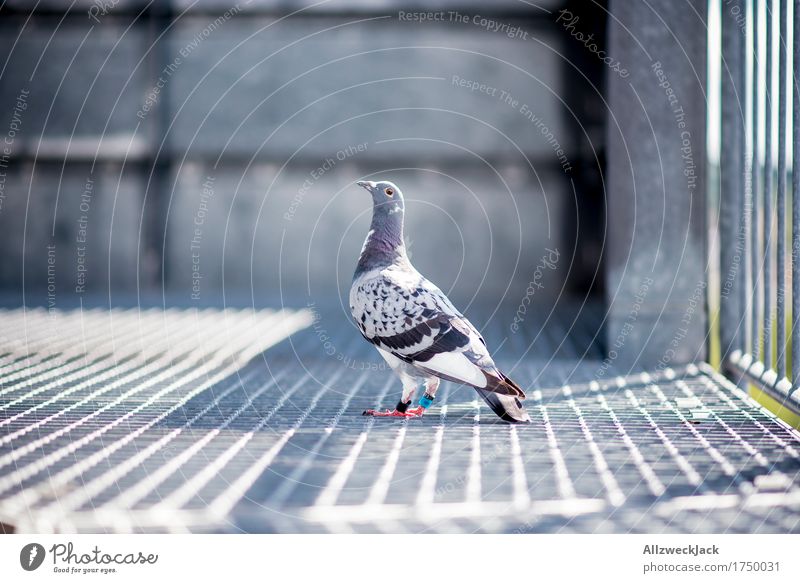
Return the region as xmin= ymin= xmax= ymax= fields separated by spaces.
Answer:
xmin=0 ymin=0 xmax=600 ymax=310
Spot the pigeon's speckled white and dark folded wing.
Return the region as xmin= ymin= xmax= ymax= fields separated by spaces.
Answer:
xmin=350 ymin=270 xmax=525 ymax=399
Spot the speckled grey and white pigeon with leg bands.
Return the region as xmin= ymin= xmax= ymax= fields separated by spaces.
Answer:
xmin=350 ymin=181 xmax=530 ymax=423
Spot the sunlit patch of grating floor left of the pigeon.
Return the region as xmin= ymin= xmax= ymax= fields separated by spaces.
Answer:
xmin=0 ymin=310 xmax=311 ymax=524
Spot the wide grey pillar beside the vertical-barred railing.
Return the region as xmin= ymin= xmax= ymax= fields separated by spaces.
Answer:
xmin=606 ymin=0 xmax=708 ymax=372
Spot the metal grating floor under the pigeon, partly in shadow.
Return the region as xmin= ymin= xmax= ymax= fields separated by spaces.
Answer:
xmin=0 ymin=309 xmax=800 ymax=532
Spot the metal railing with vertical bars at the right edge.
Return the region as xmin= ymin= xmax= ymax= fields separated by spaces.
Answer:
xmin=720 ymin=0 xmax=800 ymax=414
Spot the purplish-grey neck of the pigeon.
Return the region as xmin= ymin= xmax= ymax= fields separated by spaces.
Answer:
xmin=354 ymin=205 xmax=408 ymax=277
